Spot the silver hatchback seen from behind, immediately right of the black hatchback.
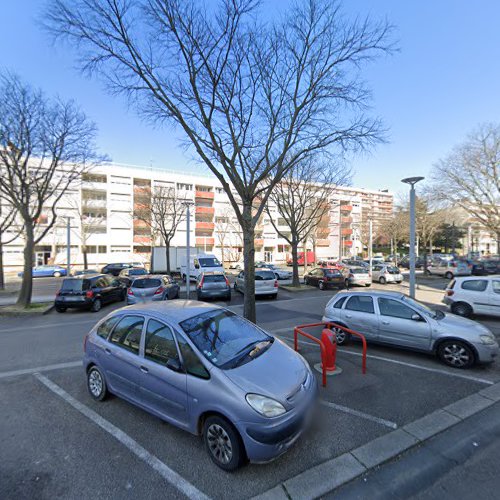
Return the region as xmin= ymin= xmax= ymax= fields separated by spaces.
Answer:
xmin=127 ymin=274 xmax=180 ymax=304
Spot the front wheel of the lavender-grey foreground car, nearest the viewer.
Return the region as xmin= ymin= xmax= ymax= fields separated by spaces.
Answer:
xmin=203 ymin=416 xmax=246 ymax=472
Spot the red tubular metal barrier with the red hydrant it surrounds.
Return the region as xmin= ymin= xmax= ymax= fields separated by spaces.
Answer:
xmin=293 ymin=321 xmax=366 ymax=387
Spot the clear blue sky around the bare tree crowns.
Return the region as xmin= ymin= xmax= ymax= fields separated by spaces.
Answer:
xmin=0 ymin=0 xmax=500 ymax=194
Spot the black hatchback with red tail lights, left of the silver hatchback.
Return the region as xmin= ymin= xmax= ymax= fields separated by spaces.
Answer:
xmin=54 ymin=274 xmax=127 ymax=312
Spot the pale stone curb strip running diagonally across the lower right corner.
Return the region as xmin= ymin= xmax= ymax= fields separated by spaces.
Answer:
xmin=253 ymin=383 xmax=500 ymax=500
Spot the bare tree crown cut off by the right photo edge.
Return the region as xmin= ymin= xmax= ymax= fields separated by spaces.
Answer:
xmin=428 ymin=124 xmax=500 ymax=251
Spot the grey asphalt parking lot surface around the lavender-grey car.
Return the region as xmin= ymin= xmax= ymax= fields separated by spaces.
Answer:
xmin=0 ymin=284 xmax=500 ymax=499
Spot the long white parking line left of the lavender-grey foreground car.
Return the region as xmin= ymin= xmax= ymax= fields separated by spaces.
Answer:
xmin=34 ymin=373 xmax=210 ymax=500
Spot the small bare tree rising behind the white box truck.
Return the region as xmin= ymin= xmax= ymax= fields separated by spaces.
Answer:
xmin=134 ymin=185 xmax=188 ymax=274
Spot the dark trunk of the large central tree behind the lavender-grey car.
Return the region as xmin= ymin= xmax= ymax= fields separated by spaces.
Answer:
xmin=241 ymin=205 xmax=257 ymax=323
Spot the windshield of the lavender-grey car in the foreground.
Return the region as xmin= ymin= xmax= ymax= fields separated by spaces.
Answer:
xmin=180 ymin=309 xmax=274 ymax=370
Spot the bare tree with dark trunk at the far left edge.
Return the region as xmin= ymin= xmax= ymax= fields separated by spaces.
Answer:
xmin=0 ymin=75 xmax=101 ymax=307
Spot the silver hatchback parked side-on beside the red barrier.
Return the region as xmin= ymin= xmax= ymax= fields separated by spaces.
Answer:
xmin=323 ymin=290 xmax=500 ymax=368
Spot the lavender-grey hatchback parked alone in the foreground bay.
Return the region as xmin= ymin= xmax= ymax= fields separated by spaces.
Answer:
xmin=83 ymin=301 xmax=318 ymax=471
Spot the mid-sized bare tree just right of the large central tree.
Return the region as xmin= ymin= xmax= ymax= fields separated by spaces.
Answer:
xmin=267 ymin=157 xmax=350 ymax=286
